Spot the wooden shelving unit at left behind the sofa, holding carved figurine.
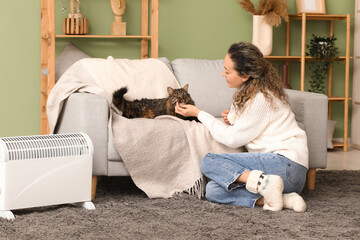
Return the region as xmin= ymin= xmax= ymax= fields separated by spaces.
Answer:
xmin=40 ymin=0 xmax=159 ymax=134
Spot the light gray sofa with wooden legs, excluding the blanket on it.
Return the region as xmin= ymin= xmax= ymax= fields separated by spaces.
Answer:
xmin=56 ymin=58 xmax=328 ymax=198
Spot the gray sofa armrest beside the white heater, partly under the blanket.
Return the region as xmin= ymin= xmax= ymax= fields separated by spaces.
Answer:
xmin=55 ymin=93 xmax=109 ymax=176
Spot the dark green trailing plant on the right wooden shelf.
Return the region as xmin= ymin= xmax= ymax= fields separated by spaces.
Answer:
xmin=305 ymin=34 xmax=339 ymax=94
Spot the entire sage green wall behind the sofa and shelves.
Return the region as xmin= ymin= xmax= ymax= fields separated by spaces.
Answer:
xmin=0 ymin=0 xmax=355 ymax=137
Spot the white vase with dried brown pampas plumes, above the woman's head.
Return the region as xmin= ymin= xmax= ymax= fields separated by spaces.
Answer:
xmin=238 ymin=0 xmax=289 ymax=56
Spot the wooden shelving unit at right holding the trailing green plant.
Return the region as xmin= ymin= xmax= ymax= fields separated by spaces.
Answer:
xmin=265 ymin=13 xmax=351 ymax=152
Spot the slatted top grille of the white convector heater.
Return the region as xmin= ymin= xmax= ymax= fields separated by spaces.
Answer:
xmin=0 ymin=133 xmax=93 ymax=161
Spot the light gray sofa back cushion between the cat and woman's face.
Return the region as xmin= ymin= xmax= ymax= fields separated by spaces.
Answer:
xmin=171 ymin=59 xmax=235 ymax=117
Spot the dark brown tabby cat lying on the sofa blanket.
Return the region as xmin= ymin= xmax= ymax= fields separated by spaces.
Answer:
xmin=112 ymin=84 xmax=198 ymax=121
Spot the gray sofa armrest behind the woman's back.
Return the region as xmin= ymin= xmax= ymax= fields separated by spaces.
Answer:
xmin=285 ymin=89 xmax=328 ymax=168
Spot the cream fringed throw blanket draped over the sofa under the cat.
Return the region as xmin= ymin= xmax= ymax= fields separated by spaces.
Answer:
xmin=47 ymin=57 xmax=242 ymax=198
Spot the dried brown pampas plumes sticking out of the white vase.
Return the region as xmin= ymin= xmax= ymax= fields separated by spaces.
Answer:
xmin=238 ymin=0 xmax=289 ymax=27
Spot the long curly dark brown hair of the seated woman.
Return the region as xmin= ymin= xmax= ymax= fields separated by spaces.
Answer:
xmin=228 ymin=42 xmax=288 ymax=112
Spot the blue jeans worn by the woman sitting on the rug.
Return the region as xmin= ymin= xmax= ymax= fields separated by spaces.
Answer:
xmin=201 ymin=152 xmax=307 ymax=207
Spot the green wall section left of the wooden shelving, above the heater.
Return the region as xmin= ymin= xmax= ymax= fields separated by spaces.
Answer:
xmin=0 ymin=0 xmax=40 ymax=137
